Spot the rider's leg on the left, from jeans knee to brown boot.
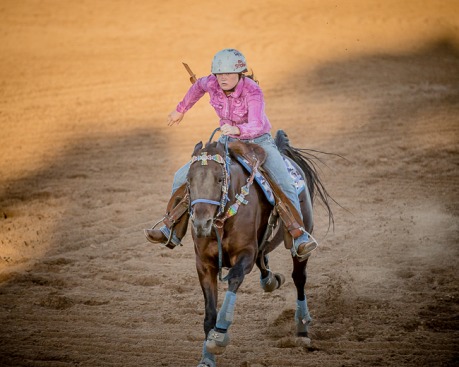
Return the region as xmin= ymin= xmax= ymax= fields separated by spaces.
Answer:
xmin=144 ymin=163 xmax=190 ymax=248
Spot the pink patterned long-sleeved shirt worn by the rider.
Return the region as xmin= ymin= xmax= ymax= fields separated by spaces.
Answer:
xmin=177 ymin=74 xmax=271 ymax=139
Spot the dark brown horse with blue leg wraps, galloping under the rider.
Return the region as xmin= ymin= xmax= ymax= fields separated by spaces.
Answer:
xmin=187 ymin=131 xmax=333 ymax=367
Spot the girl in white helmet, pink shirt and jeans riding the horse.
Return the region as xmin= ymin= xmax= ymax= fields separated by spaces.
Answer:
xmin=144 ymin=49 xmax=317 ymax=260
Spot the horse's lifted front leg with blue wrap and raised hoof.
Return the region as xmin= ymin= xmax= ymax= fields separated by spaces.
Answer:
xmin=206 ymin=251 xmax=255 ymax=354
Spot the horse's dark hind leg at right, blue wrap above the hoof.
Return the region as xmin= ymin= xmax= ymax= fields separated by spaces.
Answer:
xmin=292 ymin=258 xmax=312 ymax=337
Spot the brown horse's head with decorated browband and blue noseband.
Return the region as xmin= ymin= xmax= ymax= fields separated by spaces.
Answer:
xmin=187 ymin=143 xmax=227 ymax=237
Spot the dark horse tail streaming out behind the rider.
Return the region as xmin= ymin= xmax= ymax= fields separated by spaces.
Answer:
xmin=275 ymin=130 xmax=335 ymax=230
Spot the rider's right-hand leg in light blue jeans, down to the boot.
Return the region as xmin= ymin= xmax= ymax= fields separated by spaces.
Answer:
xmin=255 ymin=135 xmax=317 ymax=259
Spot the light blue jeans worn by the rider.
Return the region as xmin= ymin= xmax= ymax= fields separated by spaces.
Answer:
xmin=172 ymin=134 xmax=308 ymax=243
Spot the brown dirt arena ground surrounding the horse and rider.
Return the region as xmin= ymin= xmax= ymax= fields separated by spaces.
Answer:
xmin=0 ymin=0 xmax=459 ymax=367
